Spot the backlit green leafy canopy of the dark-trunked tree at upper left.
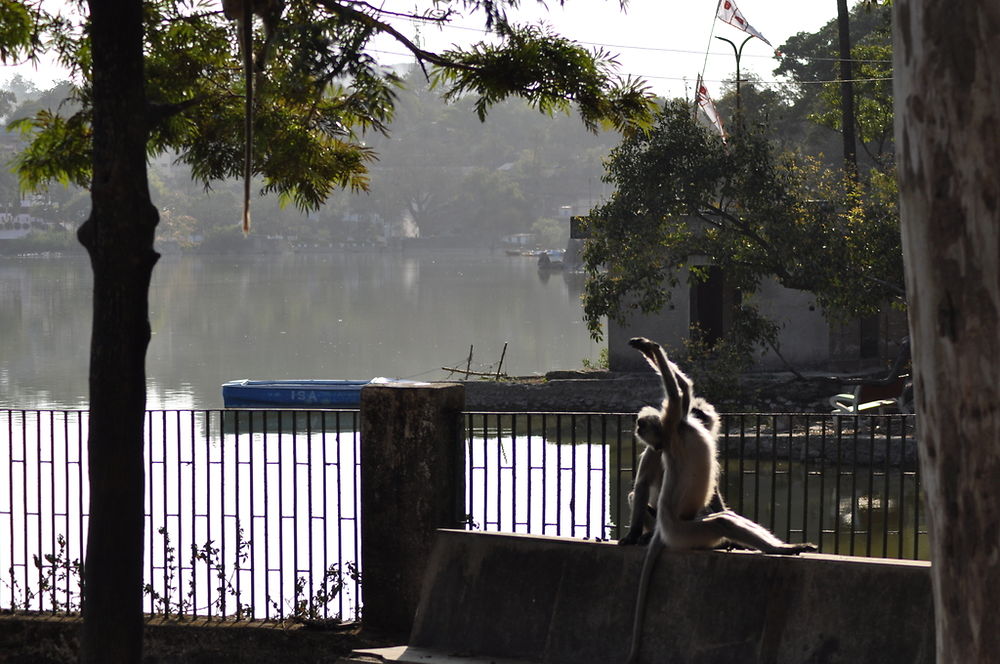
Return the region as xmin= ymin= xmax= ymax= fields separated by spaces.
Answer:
xmin=0 ymin=0 xmax=651 ymax=210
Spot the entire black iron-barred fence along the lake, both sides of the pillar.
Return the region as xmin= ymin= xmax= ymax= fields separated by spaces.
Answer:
xmin=0 ymin=410 xmax=928 ymax=620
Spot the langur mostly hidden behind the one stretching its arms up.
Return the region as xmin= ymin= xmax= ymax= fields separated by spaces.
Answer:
xmin=618 ymin=390 xmax=727 ymax=545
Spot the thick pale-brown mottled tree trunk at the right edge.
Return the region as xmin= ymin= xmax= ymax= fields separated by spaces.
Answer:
xmin=893 ymin=0 xmax=1000 ymax=662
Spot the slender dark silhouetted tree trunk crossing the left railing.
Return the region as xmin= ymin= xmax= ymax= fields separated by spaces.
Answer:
xmin=79 ymin=0 xmax=158 ymax=664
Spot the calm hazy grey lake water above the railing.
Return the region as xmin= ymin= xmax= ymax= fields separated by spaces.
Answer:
xmin=0 ymin=249 xmax=600 ymax=408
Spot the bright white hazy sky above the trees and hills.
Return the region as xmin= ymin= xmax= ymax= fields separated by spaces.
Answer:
xmin=0 ymin=0 xmax=837 ymax=96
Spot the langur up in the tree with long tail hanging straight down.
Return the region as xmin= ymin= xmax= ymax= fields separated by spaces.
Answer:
xmin=222 ymin=0 xmax=285 ymax=235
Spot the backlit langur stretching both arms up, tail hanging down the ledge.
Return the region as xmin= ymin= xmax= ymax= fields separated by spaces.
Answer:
xmin=628 ymin=337 xmax=816 ymax=663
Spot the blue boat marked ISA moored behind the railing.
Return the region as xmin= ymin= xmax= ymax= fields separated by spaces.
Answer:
xmin=222 ymin=378 xmax=397 ymax=408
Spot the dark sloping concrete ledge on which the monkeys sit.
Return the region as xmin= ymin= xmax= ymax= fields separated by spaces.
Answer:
xmin=348 ymin=531 xmax=934 ymax=664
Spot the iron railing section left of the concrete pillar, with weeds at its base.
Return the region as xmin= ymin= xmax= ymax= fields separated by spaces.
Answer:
xmin=0 ymin=410 xmax=360 ymax=620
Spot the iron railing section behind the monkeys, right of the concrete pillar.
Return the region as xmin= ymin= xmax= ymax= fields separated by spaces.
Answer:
xmin=466 ymin=413 xmax=929 ymax=559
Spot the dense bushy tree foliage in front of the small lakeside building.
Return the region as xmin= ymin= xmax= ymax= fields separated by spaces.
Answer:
xmin=584 ymin=97 xmax=903 ymax=354
